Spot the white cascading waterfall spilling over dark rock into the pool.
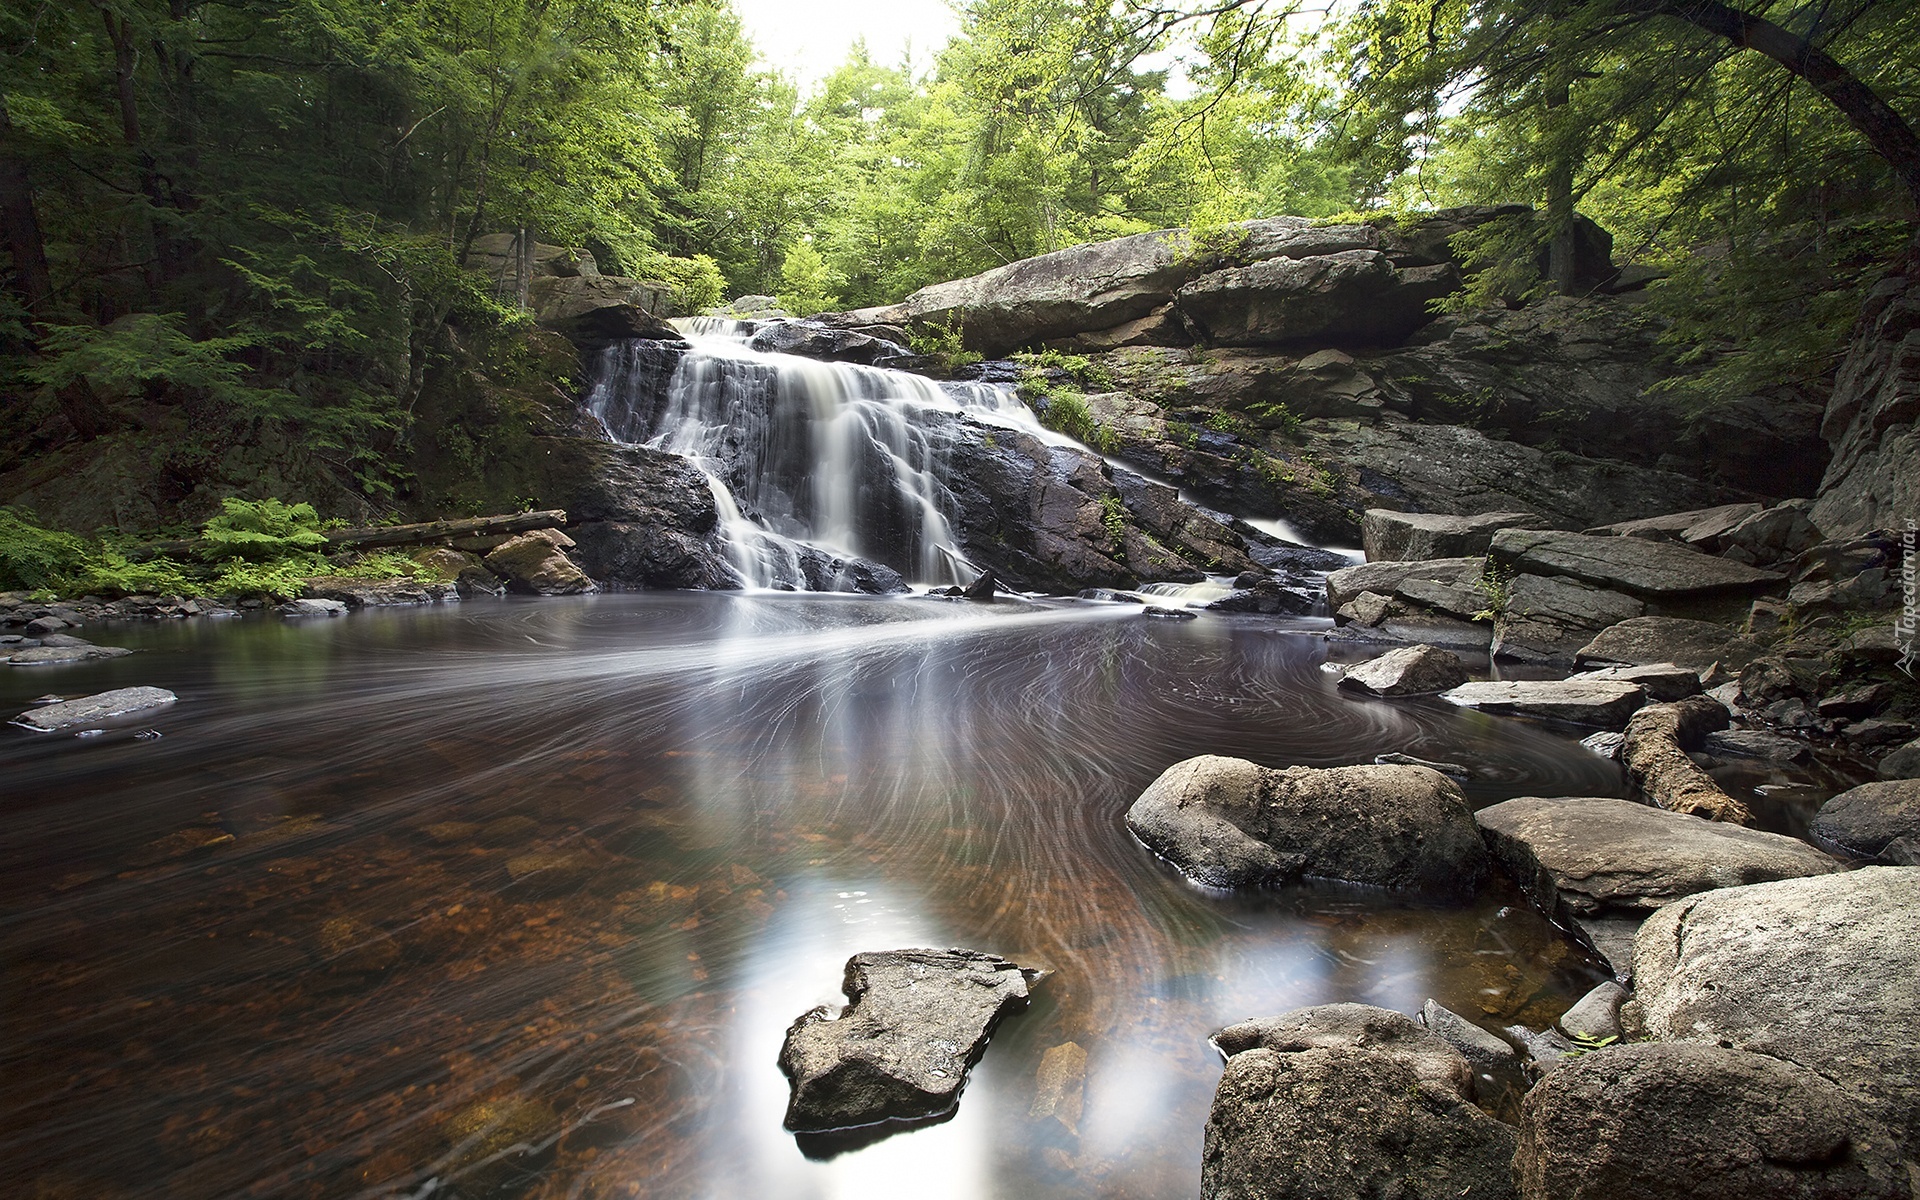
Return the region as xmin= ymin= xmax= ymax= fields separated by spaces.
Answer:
xmin=586 ymin=317 xmax=1041 ymax=589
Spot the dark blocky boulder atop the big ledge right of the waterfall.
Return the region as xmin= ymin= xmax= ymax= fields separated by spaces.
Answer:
xmin=1173 ymin=250 xmax=1459 ymax=346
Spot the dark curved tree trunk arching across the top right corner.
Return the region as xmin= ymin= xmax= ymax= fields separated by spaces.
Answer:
xmin=1617 ymin=0 xmax=1920 ymax=211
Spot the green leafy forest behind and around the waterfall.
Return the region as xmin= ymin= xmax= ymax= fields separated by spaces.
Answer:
xmin=0 ymin=0 xmax=1920 ymax=522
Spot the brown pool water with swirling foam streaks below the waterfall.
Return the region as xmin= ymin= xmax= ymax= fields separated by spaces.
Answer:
xmin=0 ymin=593 xmax=1651 ymax=1200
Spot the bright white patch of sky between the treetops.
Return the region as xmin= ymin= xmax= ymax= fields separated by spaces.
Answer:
xmin=733 ymin=0 xmax=960 ymax=88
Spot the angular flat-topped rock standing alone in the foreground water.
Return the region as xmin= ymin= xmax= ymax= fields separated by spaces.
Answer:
xmin=780 ymin=950 xmax=1037 ymax=1133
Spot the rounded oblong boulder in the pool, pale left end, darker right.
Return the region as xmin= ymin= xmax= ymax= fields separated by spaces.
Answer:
xmin=1127 ymin=755 xmax=1490 ymax=900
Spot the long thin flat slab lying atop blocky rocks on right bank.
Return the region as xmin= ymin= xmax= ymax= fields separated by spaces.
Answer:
xmin=1488 ymin=530 xmax=1786 ymax=599
